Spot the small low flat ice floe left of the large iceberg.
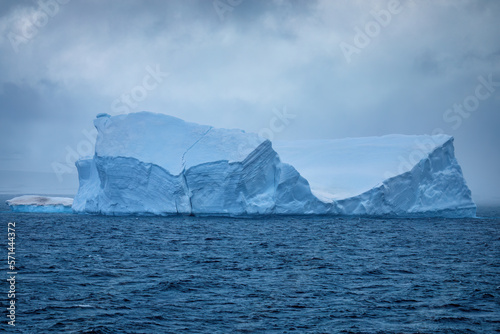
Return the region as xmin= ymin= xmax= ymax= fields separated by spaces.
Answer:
xmin=7 ymin=195 xmax=73 ymax=213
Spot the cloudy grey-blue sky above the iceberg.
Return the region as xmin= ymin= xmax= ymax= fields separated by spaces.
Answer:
xmin=0 ymin=0 xmax=500 ymax=204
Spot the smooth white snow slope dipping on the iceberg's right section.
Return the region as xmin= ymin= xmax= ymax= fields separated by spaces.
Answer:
xmin=273 ymin=135 xmax=451 ymax=202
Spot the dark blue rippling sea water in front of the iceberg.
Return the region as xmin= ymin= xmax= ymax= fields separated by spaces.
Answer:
xmin=0 ymin=194 xmax=500 ymax=333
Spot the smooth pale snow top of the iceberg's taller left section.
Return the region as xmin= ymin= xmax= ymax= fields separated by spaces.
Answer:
xmin=94 ymin=112 xmax=264 ymax=175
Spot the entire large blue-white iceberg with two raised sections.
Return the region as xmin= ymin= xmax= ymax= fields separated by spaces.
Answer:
xmin=73 ymin=112 xmax=476 ymax=217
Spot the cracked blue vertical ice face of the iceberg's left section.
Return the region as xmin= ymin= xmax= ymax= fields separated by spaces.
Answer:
xmin=73 ymin=141 xmax=326 ymax=216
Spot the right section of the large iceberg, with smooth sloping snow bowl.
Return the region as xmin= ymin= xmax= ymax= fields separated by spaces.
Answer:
xmin=273 ymin=135 xmax=476 ymax=217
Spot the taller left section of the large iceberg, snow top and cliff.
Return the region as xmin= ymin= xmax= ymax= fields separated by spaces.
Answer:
xmin=73 ymin=112 xmax=329 ymax=216
